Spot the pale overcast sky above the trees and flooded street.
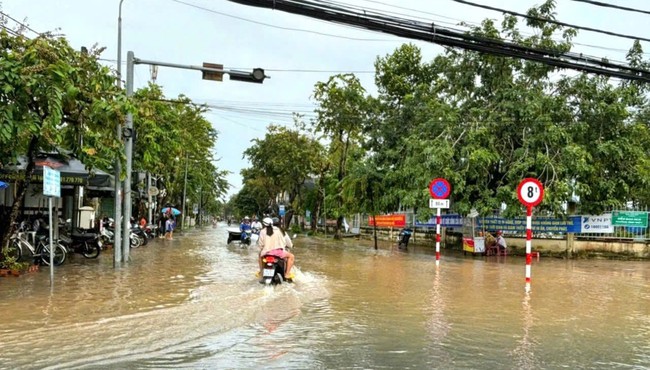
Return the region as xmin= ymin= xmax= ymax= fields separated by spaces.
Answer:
xmin=0 ymin=0 xmax=650 ymax=197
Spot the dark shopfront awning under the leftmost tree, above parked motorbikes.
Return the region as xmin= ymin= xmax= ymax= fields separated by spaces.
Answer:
xmin=0 ymin=155 xmax=114 ymax=190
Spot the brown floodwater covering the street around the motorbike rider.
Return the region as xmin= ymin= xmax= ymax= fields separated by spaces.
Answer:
xmin=0 ymin=225 xmax=650 ymax=369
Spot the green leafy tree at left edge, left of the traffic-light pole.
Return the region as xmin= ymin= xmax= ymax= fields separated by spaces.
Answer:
xmin=0 ymin=30 xmax=126 ymax=249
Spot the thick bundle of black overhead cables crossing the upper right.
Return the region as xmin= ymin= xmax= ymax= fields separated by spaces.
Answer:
xmin=224 ymin=0 xmax=650 ymax=82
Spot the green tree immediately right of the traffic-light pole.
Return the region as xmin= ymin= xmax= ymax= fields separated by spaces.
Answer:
xmin=134 ymin=84 xmax=229 ymax=220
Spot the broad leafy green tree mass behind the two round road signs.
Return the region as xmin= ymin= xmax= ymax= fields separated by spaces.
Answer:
xmin=367 ymin=1 xmax=648 ymax=218
